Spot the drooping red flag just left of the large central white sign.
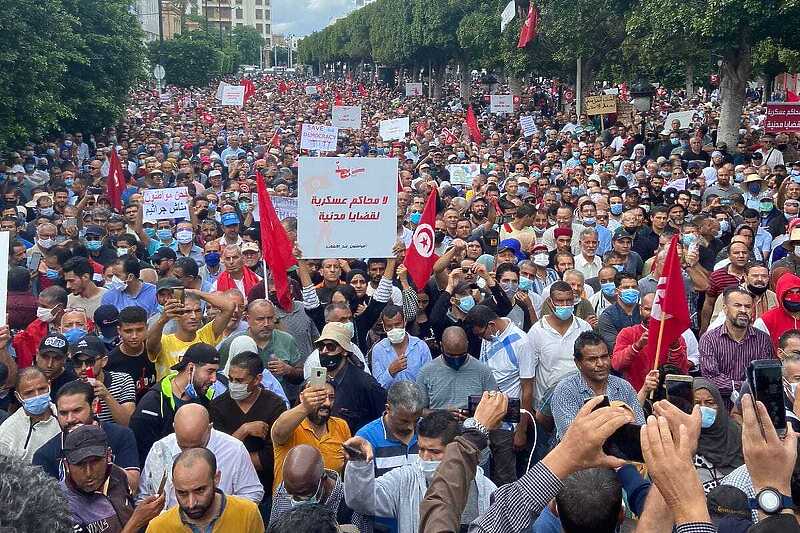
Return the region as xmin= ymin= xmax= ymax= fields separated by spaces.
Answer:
xmin=256 ymin=172 xmax=297 ymax=311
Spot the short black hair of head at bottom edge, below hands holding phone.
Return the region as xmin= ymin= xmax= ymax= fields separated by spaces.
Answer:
xmin=556 ymin=468 xmax=622 ymax=533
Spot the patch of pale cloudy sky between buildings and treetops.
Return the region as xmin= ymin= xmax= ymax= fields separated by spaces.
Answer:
xmin=272 ymin=0 xmax=354 ymax=36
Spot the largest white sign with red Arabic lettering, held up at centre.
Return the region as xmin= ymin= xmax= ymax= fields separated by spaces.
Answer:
xmin=297 ymin=157 xmax=398 ymax=259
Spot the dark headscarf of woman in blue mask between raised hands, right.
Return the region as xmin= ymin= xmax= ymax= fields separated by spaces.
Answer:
xmin=692 ymin=378 xmax=744 ymax=472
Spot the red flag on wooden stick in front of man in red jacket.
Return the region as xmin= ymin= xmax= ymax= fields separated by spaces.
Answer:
xmin=646 ymin=235 xmax=691 ymax=369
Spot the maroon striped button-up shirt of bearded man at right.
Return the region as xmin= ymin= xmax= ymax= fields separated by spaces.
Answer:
xmin=700 ymin=322 xmax=775 ymax=398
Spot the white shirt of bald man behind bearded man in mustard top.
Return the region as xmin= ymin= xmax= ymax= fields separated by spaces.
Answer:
xmin=137 ymin=429 xmax=262 ymax=510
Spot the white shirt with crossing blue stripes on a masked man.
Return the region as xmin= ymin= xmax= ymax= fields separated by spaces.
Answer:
xmin=480 ymin=319 xmax=535 ymax=398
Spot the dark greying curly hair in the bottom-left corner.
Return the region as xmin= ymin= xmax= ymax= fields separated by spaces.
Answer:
xmin=0 ymin=454 xmax=73 ymax=533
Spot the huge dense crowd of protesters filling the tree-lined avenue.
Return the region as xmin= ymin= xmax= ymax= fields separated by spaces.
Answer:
xmin=0 ymin=71 xmax=800 ymax=533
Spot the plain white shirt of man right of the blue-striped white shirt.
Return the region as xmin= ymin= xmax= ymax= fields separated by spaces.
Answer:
xmin=528 ymin=315 xmax=592 ymax=402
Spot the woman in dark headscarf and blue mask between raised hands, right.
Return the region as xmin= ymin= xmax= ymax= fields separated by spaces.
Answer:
xmin=692 ymin=378 xmax=744 ymax=493
